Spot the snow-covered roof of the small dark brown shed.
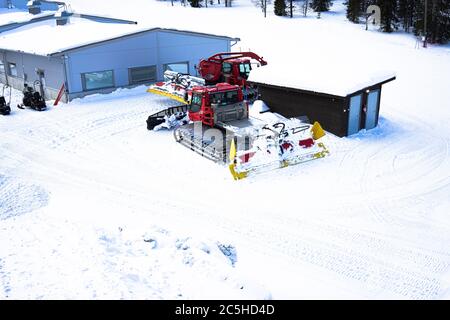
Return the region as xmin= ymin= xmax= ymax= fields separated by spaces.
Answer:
xmin=249 ymin=61 xmax=395 ymax=97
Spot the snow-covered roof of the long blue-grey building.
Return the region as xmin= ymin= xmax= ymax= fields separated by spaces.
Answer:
xmin=0 ymin=17 xmax=239 ymax=56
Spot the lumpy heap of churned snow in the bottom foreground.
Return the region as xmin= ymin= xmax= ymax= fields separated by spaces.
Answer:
xmin=98 ymin=226 xmax=270 ymax=299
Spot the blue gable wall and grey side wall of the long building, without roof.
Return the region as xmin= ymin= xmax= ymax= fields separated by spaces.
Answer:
xmin=0 ymin=30 xmax=236 ymax=99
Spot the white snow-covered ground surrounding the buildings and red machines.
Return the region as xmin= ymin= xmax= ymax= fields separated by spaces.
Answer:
xmin=0 ymin=0 xmax=450 ymax=299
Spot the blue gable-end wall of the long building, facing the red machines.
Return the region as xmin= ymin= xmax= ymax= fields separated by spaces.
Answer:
xmin=67 ymin=31 xmax=230 ymax=97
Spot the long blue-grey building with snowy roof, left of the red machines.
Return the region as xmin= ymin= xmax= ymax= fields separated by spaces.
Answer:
xmin=0 ymin=17 xmax=239 ymax=101
